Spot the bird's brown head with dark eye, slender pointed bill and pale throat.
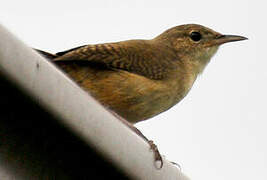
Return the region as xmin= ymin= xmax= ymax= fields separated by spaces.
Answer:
xmin=155 ymin=24 xmax=247 ymax=74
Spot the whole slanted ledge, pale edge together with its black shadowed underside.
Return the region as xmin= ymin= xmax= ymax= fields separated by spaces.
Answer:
xmin=0 ymin=26 xmax=191 ymax=180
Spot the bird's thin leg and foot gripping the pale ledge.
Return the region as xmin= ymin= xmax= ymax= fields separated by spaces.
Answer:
xmin=111 ymin=111 xmax=163 ymax=169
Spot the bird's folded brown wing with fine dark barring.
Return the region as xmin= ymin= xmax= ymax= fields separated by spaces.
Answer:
xmin=38 ymin=43 xmax=176 ymax=79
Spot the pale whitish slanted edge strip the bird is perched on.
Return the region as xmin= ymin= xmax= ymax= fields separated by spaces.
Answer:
xmin=0 ymin=25 xmax=191 ymax=180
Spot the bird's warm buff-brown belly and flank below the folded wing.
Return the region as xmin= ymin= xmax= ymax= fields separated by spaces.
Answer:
xmin=59 ymin=63 xmax=184 ymax=123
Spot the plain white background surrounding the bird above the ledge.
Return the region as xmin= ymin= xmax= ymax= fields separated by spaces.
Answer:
xmin=0 ymin=0 xmax=267 ymax=180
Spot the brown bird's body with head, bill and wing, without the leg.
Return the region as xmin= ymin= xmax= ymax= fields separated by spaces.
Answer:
xmin=37 ymin=24 xmax=247 ymax=167
